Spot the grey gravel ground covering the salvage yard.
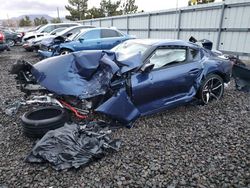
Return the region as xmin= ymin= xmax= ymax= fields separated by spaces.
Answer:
xmin=0 ymin=47 xmax=250 ymax=188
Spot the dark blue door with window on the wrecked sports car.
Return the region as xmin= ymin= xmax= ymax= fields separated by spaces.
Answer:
xmin=131 ymin=46 xmax=202 ymax=115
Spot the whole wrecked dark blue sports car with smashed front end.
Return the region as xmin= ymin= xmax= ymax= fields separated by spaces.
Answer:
xmin=11 ymin=39 xmax=232 ymax=125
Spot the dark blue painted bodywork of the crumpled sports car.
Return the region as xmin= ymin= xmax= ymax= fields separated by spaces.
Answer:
xmin=25 ymin=40 xmax=232 ymax=124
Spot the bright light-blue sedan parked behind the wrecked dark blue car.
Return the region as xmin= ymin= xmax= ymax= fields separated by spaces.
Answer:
xmin=38 ymin=28 xmax=134 ymax=58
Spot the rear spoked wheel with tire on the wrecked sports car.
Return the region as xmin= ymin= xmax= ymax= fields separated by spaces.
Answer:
xmin=198 ymin=74 xmax=224 ymax=104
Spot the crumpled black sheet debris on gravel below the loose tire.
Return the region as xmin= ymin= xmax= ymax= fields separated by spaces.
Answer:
xmin=25 ymin=122 xmax=121 ymax=170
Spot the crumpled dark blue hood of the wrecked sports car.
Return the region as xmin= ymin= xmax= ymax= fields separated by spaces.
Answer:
xmin=31 ymin=50 xmax=141 ymax=99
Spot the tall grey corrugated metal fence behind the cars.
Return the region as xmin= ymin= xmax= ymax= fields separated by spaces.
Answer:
xmin=79 ymin=0 xmax=250 ymax=57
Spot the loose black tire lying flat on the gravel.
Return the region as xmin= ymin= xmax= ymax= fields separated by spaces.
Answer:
xmin=21 ymin=106 xmax=69 ymax=138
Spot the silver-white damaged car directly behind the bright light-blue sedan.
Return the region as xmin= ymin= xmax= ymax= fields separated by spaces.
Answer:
xmin=32 ymin=25 xmax=94 ymax=50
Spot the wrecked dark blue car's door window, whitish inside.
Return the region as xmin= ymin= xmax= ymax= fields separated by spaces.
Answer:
xmin=149 ymin=48 xmax=186 ymax=69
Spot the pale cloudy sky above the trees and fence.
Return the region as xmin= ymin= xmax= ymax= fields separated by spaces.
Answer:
xmin=0 ymin=0 xmax=219 ymax=19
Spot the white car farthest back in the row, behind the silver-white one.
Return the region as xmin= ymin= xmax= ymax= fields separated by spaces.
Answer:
xmin=22 ymin=23 xmax=81 ymax=42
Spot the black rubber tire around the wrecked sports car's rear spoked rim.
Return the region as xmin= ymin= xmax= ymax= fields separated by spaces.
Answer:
xmin=197 ymin=74 xmax=224 ymax=104
